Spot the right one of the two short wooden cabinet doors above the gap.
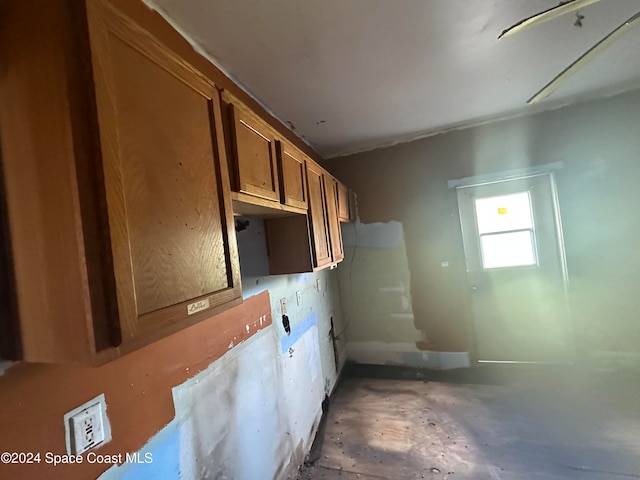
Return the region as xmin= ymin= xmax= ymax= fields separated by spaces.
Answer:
xmin=277 ymin=141 xmax=307 ymax=209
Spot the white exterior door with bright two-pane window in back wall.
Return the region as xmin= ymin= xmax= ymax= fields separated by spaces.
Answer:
xmin=457 ymin=174 xmax=573 ymax=362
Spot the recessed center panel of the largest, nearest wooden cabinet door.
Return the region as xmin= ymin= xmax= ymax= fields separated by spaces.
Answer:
xmin=111 ymin=46 xmax=227 ymax=314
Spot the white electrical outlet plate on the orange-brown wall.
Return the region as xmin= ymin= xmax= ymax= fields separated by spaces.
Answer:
xmin=64 ymin=395 xmax=111 ymax=455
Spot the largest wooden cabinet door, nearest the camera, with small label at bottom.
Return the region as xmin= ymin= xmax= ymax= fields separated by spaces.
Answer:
xmin=87 ymin=0 xmax=241 ymax=344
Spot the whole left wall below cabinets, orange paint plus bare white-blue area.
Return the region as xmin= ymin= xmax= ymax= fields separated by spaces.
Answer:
xmin=0 ymin=219 xmax=345 ymax=480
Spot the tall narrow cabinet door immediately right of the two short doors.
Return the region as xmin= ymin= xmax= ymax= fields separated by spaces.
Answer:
xmin=307 ymin=161 xmax=331 ymax=268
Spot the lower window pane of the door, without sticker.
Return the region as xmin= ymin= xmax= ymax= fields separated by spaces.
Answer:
xmin=480 ymin=230 xmax=537 ymax=269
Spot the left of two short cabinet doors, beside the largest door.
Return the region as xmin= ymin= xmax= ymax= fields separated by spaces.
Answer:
xmin=229 ymin=97 xmax=280 ymax=202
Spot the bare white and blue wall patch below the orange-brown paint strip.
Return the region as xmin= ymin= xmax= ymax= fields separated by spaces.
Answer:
xmin=101 ymin=324 xmax=324 ymax=480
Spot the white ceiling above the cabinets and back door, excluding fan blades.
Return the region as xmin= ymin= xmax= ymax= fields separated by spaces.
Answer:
xmin=145 ymin=0 xmax=640 ymax=157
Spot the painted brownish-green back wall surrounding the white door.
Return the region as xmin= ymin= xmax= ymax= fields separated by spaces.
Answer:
xmin=328 ymin=91 xmax=640 ymax=362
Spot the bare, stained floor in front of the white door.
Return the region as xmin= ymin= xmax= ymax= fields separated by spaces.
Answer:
xmin=300 ymin=366 xmax=640 ymax=480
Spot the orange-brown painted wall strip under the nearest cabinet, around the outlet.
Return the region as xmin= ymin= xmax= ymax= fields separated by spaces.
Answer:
xmin=0 ymin=293 xmax=271 ymax=478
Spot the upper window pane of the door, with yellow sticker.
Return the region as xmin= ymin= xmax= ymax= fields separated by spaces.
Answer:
xmin=476 ymin=192 xmax=533 ymax=235
